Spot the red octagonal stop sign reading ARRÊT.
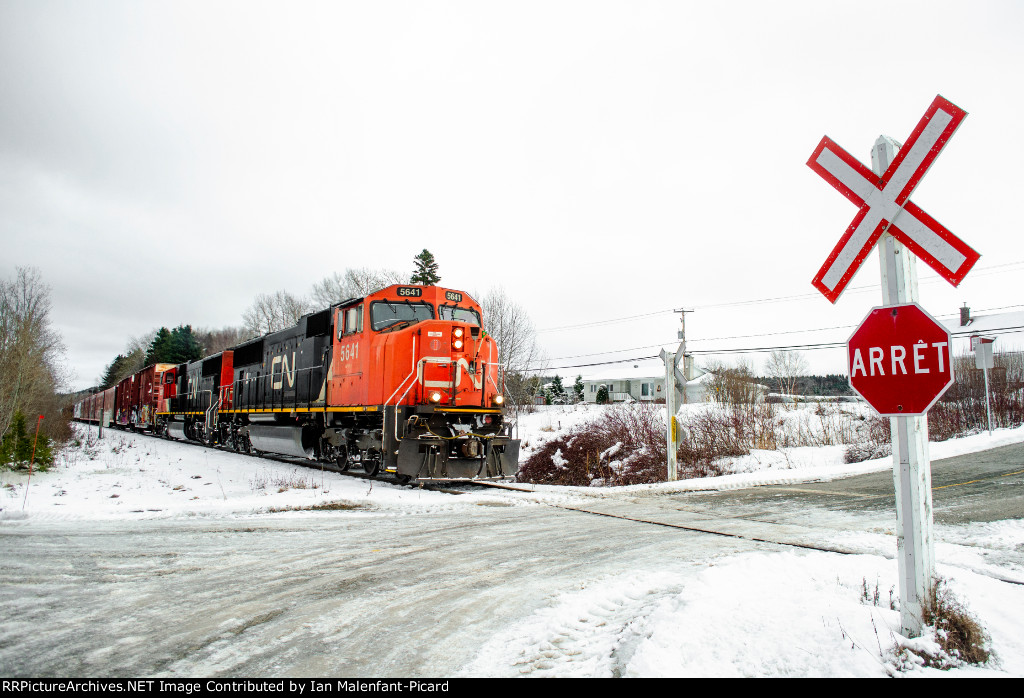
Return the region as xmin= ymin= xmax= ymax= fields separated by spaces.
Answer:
xmin=846 ymin=303 xmax=953 ymax=417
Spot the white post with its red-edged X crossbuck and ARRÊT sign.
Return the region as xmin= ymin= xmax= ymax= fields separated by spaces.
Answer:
xmin=807 ymin=96 xmax=980 ymax=637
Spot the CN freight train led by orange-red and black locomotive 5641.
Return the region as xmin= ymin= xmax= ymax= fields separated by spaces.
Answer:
xmin=74 ymin=285 xmax=519 ymax=482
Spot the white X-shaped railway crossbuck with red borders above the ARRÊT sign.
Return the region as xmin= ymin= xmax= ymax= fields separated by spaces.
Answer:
xmin=807 ymin=96 xmax=981 ymax=303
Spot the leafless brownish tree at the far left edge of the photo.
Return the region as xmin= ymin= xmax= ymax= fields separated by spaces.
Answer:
xmin=0 ymin=267 xmax=67 ymax=438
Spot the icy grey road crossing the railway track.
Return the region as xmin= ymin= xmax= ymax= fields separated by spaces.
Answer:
xmin=0 ymin=446 xmax=1024 ymax=677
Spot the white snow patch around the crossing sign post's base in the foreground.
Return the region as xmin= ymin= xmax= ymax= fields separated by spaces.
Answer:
xmin=464 ymin=552 xmax=1024 ymax=678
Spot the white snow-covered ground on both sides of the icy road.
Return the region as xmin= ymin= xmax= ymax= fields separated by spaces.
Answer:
xmin=0 ymin=415 xmax=1024 ymax=677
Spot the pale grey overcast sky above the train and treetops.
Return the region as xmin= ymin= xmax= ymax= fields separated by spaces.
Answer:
xmin=0 ymin=0 xmax=1024 ymax=387
